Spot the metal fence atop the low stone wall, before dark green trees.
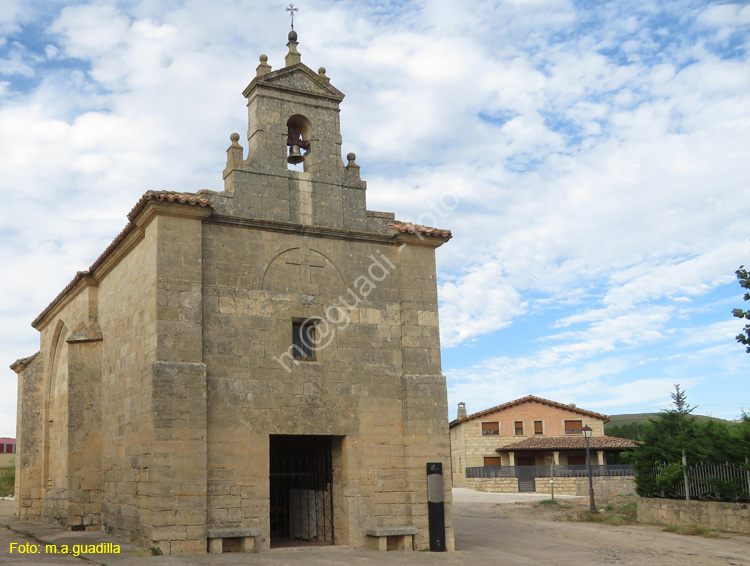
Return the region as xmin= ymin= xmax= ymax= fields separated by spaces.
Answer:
xmin=646 ymin=463 xmax=750 ymax=501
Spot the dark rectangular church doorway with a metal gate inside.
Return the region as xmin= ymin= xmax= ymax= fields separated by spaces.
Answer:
xmin=270 ymin=435 xmax=333 ymax=547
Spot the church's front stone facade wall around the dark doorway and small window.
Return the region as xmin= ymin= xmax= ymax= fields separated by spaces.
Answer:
xmin=203 ymin=219 xmax=453 ymax=548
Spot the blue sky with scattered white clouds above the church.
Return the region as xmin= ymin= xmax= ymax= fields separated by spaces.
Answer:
xmin=0 ymin=0 xmax=750 ymax=436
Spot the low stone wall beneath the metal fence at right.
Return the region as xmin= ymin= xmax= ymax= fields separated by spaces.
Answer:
xmin=638 ymin=497 xmax=750 ymax=534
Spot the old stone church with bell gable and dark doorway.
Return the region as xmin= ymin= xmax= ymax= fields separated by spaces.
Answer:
xmin=11 ymin=31 xmax=453 ymax=554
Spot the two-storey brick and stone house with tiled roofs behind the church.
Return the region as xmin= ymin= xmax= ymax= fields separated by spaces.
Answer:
xmin=450 ymin=395 xmax=635 ymax=486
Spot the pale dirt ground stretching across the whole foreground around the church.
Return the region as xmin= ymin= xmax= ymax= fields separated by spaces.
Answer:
xmin=0 ymin=490 xmax=750 ymax=566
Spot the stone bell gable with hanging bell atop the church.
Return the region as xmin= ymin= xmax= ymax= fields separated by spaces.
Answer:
xmin=217 ymin=30 xmax=374 ymax=232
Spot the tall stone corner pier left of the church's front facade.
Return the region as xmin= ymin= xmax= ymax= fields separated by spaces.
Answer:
xmin=145 ymin=213 xmax=210 ymax=554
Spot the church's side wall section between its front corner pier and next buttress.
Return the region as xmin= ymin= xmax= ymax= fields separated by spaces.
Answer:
xmin=99 ymin=215 xmax=158 ymax=542
